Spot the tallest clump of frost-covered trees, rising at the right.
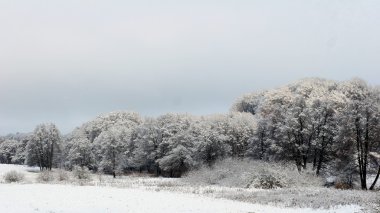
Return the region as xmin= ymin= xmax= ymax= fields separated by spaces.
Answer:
xmin=232 ymin=79 xmax=379 ymax=183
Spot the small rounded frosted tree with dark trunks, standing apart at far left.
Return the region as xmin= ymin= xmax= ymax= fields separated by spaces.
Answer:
xmin=26 ymin=123 xmax=61 ymax=170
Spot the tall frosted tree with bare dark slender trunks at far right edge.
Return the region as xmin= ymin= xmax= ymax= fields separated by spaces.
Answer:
xmin=339 ymin=80 xmax=380 ymax=189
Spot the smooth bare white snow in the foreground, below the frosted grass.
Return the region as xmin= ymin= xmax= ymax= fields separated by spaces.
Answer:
xmin=0 ymin=184 xmax=360 ymax=213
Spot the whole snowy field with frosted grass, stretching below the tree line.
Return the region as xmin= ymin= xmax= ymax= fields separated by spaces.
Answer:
xmin=0 ymin=165 xmax=378 ymax=213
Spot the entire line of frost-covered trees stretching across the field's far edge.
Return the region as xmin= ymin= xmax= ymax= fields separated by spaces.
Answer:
xmin=0 ymin=79 xmax=380 ymax=189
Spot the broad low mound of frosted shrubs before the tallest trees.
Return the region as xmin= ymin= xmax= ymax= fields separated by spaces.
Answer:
xmin=185 ymin=158 xmax=323 ymax=189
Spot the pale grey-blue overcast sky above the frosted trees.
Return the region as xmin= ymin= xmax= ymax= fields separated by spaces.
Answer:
xmin=0 ymin=0 xmax=380 ymax=134
